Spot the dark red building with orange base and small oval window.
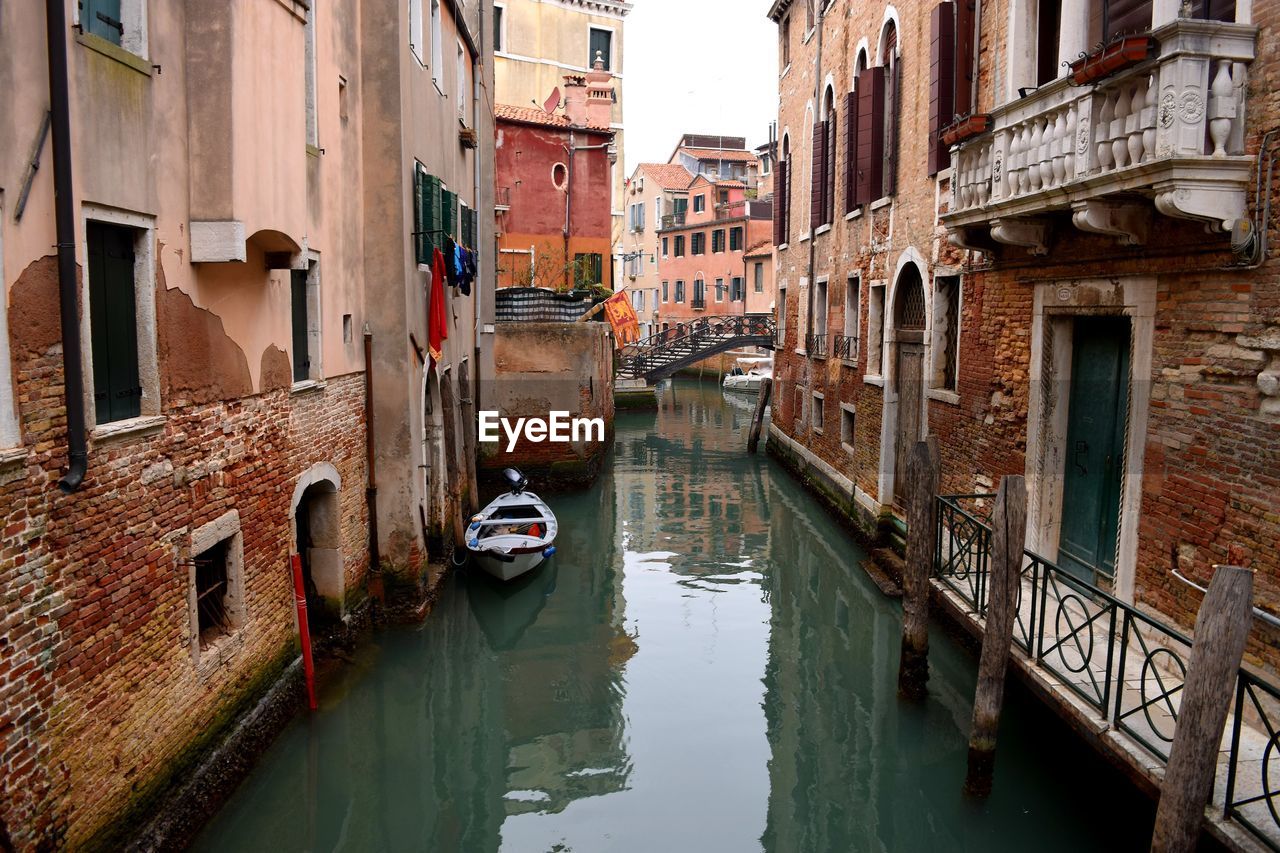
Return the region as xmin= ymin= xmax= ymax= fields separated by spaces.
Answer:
xmin=494 ymin=63 xmax=617 ymax=289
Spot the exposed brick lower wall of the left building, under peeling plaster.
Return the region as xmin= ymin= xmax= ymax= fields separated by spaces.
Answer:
xmin=0 ymin=258 xmax=367 ymax=849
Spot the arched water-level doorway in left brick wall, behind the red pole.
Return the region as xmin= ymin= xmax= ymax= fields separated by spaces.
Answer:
xmin=293 ymin=462 xmax=347 ymax=633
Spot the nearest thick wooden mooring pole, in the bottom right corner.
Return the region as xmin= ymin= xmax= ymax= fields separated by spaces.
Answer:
xmin=1151 ymin=566 xmax=1253 ymax=853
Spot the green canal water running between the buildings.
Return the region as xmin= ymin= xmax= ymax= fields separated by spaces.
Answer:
xmin=197 ymin=380 xmax=1152 ymax=853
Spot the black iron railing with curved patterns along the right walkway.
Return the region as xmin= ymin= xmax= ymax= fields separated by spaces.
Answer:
xmin=933 ymin=494 xmax=1280 ymax=850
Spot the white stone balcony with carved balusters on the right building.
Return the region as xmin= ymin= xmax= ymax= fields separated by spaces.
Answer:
xmin=941 ymin=19 xmax=1257 ymax=255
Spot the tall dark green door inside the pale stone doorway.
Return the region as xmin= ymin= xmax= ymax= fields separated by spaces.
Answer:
xmin=1059 ymin=318 xmax=1129 ymax=583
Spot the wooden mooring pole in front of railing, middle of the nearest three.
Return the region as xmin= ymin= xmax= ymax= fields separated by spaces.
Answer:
xmin=964 ymin=475 xmax=1027 ymax=797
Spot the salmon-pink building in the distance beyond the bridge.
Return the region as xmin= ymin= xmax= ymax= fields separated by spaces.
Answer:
xmin=658 ymin=175 xmax=773 ymax=329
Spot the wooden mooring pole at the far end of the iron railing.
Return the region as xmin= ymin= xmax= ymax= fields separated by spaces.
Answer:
xmin=897 ymin=435 xmax=942 ymax=699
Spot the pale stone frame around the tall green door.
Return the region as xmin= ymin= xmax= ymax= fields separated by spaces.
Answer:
xmin=1027 ymin=277 xmax=1157 ymax=602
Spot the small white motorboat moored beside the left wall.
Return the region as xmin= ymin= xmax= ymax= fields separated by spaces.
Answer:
xmin=467 ymin=467 xmax=559 ymax=580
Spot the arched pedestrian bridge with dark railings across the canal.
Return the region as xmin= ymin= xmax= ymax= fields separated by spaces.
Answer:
xmin=617 ymin=314 xmax=776 ymax=383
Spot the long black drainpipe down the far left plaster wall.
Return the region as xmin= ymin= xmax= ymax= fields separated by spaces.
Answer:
xmin=45 ymin=0 xmax=88 ymax=494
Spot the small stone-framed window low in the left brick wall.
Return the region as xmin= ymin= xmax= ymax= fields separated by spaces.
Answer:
xmin=187 ymin=510 xmax=244 ymax=661
